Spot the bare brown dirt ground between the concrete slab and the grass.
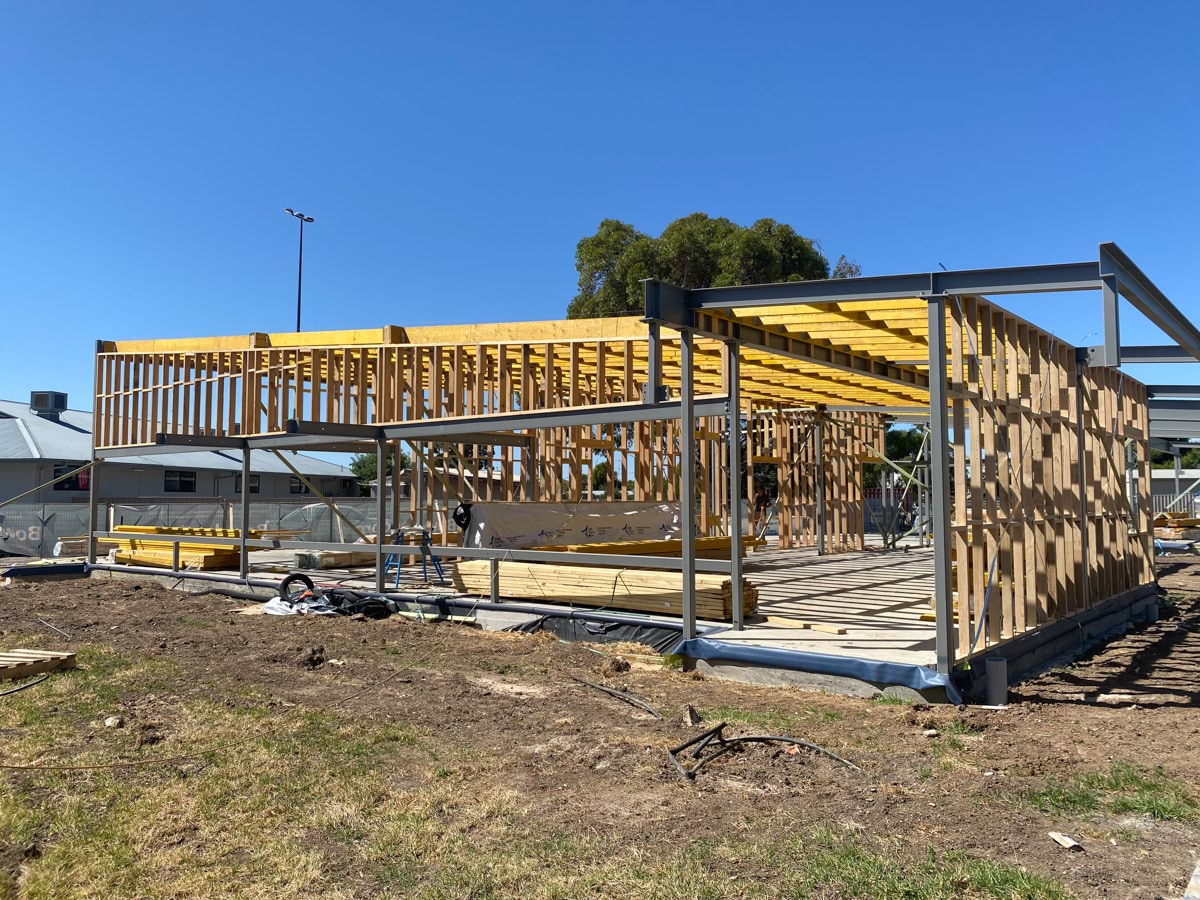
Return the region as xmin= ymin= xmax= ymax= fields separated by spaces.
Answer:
xmin=0 ymin=558 xmax=1200 ymax=898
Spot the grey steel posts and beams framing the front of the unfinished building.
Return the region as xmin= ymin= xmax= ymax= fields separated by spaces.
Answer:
xmin=89 ymin=244 xmax=1200 ymax=673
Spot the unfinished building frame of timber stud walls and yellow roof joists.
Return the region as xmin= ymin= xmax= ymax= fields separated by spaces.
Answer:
xmin=90 ymin=245 xmax=1200 ymax=674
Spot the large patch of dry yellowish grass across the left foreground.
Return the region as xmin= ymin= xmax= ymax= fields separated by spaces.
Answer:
xmin=0 ymin=647 xmax=1067 ymax=900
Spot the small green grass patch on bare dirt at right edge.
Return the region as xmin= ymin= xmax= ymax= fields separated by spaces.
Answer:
xmin=1016 ymin=761 xmax=1200 ymax=822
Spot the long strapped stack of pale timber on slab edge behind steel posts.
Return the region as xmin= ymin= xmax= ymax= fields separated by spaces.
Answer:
xmin=454 ymin=559 xmax=758 ymax=622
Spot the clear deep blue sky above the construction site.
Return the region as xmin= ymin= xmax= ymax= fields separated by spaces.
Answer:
xmin=0 ymin=1 xmax=1200 ymax=407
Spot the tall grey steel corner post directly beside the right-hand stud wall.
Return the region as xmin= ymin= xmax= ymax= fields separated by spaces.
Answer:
xmin=929 ymin=296 xmax=967 ymax=674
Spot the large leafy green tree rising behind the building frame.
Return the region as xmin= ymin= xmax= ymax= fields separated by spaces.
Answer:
xmin=566 ymin=212 xmax=844 ymax=319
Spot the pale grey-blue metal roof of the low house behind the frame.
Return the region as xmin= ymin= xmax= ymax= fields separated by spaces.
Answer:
xmin=0 ymin=400 xmax=354 ymax=478
